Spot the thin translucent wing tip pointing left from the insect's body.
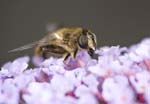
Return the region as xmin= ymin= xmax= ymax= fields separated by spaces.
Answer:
xmin=8 ymin=41 xmax=38 ymax=52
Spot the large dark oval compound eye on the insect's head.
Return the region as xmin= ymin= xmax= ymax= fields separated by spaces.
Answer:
xmin=78 ymin=35 xmax=88 ymax=49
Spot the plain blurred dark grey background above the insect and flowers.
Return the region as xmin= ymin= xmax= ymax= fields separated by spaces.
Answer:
xmin=0 ymin=0 xmax=150 ymax=65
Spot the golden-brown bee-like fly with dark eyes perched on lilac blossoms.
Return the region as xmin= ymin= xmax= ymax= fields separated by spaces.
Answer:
xmin=9 ymin=27 xmax=97 ymax=61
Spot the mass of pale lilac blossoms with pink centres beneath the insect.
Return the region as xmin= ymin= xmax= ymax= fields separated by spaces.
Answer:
xmin=0 ymin=38 xmax=150 ymax=104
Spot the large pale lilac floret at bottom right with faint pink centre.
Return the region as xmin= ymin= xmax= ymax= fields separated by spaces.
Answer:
xmin=102 ymin=76 xmax=134 ymax=104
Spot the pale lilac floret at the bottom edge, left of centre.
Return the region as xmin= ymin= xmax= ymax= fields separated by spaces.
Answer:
xmin=23 ymin=82 xmax=54 ymax=104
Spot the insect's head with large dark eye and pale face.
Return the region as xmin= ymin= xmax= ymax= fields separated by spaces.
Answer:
xmin=78 ymin=29 xmax=97 ymax=57
